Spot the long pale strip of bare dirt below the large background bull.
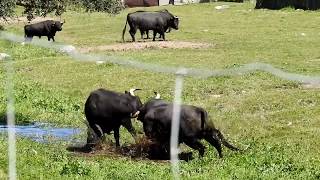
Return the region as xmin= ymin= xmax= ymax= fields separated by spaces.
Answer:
xmin=78 ymin=41 xmax=213 ymax=53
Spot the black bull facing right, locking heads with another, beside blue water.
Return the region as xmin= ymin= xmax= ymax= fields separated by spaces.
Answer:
xmin=84 ymin=89 xmax=142 ymax=147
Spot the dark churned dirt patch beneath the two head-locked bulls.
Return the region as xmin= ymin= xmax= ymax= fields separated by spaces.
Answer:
xmin=67 ymin=137 xmax=193 ymax=162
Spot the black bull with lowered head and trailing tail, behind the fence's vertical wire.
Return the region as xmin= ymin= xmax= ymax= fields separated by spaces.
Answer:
xmin=138 ymin=95 xmax=239 ymax=157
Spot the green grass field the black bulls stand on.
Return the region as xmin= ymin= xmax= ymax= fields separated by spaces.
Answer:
xmin=0 ymin=0 xmax=320 ymax=179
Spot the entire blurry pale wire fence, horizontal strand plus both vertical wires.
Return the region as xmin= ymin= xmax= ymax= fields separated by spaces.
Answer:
xmin=0 ymin=32 xmax=320 ymax=179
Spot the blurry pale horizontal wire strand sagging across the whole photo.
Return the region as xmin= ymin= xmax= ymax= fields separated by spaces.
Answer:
xmin=0 ymin=32 xmax=320 ymax=84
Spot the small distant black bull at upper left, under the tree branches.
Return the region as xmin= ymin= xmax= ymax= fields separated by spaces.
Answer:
xmin=24 ymin=20 xmax=65 ymax=42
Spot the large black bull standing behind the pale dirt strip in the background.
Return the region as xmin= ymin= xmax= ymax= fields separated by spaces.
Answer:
xmin=122 ymin=10 xmax=179 ymax=42
